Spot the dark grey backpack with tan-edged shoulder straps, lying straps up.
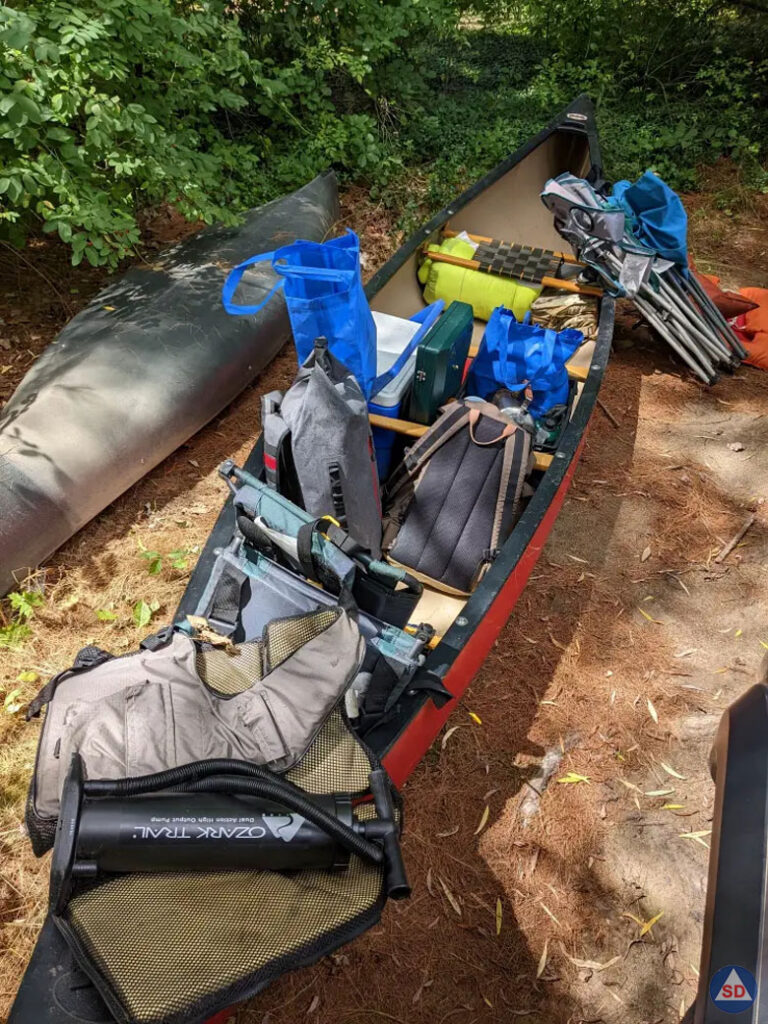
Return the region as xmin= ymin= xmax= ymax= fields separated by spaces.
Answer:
xmin=384 ymin=399 xmax=531 ymax=594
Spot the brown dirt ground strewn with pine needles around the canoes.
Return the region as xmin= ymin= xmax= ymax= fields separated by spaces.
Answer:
xmin=0 ymin=169 xmax=768 ymax=1024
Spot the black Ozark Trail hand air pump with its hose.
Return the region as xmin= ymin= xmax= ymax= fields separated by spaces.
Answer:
xmin=50 ymin=754 xmax=411 ymax=914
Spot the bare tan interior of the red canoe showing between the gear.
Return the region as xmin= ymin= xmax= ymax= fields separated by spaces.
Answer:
xmin=371 ymin=131 xmax=594 ymax=639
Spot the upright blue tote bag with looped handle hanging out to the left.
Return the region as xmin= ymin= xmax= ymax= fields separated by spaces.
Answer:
xmin=221 ymin=229 xmax=376 ymax=398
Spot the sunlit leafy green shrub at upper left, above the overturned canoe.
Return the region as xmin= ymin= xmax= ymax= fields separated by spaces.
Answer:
xmin=0 ymin=0 xmax=452 ymax=266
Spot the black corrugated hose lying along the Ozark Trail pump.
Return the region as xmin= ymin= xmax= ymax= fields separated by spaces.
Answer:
xmin=83 ymin=758 xmax=384 ymax=864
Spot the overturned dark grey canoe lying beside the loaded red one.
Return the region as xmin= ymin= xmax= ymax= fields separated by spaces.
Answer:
xmin=0 ymin=173 xmax=339 ymax=595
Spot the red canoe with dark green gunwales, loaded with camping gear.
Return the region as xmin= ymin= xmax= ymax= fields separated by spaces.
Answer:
xmin=10 ymin=96 xmax=614 ymax=1024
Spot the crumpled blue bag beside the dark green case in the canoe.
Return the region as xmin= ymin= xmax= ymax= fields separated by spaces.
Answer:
xmin=466 ymin=306 xmax=584 ymax=418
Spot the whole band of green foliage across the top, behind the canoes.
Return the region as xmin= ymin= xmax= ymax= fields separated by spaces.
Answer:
xmin=0 ymin=0 xmax=768 ymax=266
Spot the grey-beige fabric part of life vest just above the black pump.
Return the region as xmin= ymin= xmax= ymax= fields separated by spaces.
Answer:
xmin=20 ymin=607 xmax=365 ymax=856
